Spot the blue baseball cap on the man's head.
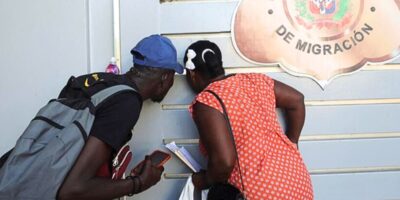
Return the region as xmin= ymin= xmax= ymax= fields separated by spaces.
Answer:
xmin=131 ymin=35 xmax=183 ymax=74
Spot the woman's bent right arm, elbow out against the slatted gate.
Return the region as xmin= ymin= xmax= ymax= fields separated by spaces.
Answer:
xmin=274 ymin=80 xmax=306 ymax=145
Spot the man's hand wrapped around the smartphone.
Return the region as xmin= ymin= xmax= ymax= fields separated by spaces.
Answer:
xmin=132 ymin=156 xmax=164 ymax=192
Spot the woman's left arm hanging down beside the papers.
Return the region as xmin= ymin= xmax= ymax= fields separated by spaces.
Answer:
xmin=193 ymin=102 xmax=236 ymax=189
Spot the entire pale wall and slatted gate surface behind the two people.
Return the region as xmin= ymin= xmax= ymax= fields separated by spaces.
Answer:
xmin=0 ymin=0 xmax=400 ymax=200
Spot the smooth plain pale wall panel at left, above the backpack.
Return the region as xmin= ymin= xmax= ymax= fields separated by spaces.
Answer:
xmin=0 ymin=0 xmax=113 ymax=154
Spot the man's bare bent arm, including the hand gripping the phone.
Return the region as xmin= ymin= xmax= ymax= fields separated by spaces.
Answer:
xmin=57 ymin=136 xmax=163 ymax=200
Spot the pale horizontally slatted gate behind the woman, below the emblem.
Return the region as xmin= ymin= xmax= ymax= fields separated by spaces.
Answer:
xmin=121 ymin=0 xmax=400 ymax=200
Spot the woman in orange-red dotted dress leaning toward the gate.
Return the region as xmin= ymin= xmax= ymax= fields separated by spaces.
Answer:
xmin=184 ymin=41 xmax=313 ymax=200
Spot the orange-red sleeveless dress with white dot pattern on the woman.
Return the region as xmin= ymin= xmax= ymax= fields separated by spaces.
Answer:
xmin=189 ymin=74 xmax=313 ymax=200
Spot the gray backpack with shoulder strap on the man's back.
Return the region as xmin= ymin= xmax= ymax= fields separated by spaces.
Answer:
xmin=0 ymin=85 xmax=135 ymax=200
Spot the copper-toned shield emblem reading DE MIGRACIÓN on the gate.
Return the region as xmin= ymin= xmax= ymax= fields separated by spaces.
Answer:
xmin=231 ymin=0 xmax=400 ymax=87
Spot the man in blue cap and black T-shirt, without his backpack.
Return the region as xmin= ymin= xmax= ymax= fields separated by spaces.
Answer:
xmin=58 ymin=35 xmax=183 ymax=200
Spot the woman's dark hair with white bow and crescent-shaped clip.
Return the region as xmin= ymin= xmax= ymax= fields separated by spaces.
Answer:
xmin=183 ymin=40 xmax=225 ymax=78
